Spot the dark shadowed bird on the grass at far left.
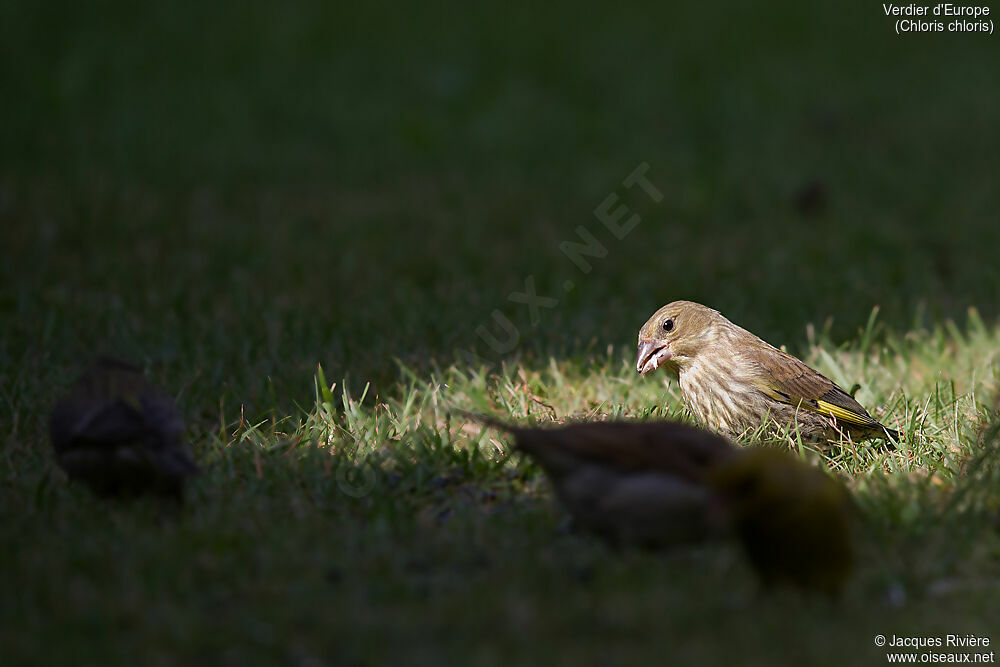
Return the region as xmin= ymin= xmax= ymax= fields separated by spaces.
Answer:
xmin=49 ymin=358 xmax=198 ymax=499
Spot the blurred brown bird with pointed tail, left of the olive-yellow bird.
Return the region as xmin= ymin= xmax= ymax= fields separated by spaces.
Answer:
xmin=473 ymin=416 xmax=736 ymax=547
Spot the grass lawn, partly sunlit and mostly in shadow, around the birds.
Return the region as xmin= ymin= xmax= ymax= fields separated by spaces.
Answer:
xmin=0 ymin=2 xmax=1000 ymax=665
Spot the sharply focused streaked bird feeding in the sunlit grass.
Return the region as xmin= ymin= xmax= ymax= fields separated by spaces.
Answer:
xmin=636 ymin=301 xmax=899 ymax=447
